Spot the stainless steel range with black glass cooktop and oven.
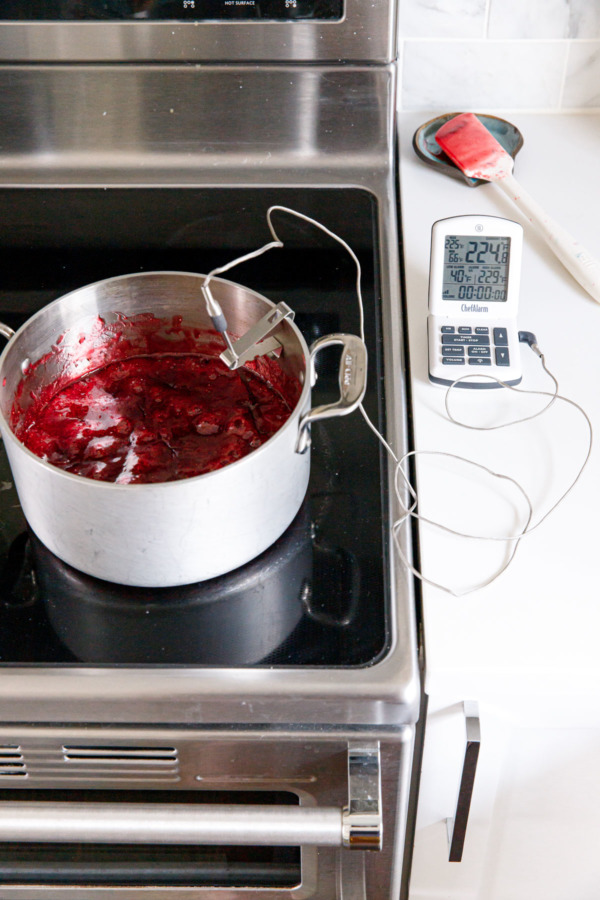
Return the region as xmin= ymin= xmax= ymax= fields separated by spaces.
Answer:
xmin=0 ymin=0 xmax=419 ymax=900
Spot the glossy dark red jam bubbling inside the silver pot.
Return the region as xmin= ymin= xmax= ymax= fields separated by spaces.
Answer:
xmin=11 ymin=318 xmax=301 ymax=484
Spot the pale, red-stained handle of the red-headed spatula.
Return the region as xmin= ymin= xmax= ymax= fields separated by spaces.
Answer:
xmin=494 ymin=175 xmax=600 ymax=303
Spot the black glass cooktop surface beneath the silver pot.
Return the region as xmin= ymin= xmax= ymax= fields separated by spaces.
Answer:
xmin=0 ymin=188 xmax=389 ymax=667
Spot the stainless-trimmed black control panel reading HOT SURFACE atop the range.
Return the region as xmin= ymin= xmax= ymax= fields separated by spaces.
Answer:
xmin=0 ymin=0 xmax=396 ymax=63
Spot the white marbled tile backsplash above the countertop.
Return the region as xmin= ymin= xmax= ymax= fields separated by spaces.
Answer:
xmin=399 ymin=0 xmax=600 ymax=112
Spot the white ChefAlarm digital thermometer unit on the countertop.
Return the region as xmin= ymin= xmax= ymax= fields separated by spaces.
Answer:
xmin=427 ymin=216 xmax=523 ymax=388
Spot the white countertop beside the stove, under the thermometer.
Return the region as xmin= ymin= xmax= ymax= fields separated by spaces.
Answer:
xmin=399 ymin=110 xmax=600 ymax=714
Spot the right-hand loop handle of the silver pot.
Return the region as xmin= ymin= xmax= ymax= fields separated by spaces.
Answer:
xmin=296 ymin=334 xmax=367 ymax=453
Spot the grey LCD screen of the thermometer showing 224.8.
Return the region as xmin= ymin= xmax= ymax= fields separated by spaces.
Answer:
xmin=442 ymin=234 xmax=511 ymax=303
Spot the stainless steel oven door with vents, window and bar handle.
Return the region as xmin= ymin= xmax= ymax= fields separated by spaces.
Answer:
xmin=0 ymin=729 xmax=410 ymax=900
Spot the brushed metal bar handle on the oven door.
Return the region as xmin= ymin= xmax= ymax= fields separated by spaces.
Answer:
xmin=0 ymin=742 xmax=382 ymax=850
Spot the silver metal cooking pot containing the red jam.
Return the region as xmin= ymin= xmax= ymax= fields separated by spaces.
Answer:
xmin=0 ymin=272 xmax=367 ymax=587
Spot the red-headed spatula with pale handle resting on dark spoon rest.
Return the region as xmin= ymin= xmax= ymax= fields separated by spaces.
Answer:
xmin=435 ymin=113 xmax=600 ymax=303
